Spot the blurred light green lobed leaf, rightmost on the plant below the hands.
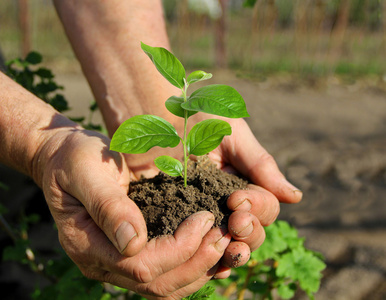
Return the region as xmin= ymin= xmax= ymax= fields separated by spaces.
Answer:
xmin=276 ymin=248 xmax=326 ymax=293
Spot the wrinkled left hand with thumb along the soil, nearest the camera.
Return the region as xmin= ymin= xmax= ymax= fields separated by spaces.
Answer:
xmin=35 ymin=128 xmax=231 ymax=299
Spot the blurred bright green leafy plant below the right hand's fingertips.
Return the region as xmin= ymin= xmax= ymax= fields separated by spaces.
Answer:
xmin=202 ymin=221 xmax=326 ymax=300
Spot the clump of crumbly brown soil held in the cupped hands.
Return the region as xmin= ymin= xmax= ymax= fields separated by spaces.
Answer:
xmin=129 ymin=156 xmax=248 ymax=239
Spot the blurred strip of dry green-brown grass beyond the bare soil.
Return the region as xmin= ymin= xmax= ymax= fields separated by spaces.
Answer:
xmin=0 ymin=0 xmax=386 ymax=78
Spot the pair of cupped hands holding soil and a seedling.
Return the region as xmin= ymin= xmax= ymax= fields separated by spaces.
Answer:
xmin=35 ymin=115 xmax=301 ymax=299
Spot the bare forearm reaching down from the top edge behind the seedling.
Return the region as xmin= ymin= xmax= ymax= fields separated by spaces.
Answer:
xmin=54 ymin=0 xmax=179 ymax=134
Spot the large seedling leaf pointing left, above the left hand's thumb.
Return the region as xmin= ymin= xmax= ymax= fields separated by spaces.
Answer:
xmin=110 ymin=115 xmax=180 ymax=154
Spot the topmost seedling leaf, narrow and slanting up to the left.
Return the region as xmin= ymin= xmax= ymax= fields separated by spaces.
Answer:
xmin=141 ymin=42 xmax=185 ymax=89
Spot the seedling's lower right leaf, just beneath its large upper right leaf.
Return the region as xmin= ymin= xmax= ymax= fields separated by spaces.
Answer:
xmin=187 ymin=119 xmax=232 ymax=156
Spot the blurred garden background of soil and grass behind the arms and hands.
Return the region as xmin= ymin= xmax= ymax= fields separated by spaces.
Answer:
xmin=0 ymin=0 xmax=386 ymax=300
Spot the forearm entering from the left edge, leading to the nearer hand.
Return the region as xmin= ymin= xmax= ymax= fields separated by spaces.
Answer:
xmin=0 ymin=72 xmax=76 ymax=185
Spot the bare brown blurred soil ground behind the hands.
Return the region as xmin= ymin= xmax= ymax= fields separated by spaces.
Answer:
xmin=0 ymin=71 xmax=386 ymax=300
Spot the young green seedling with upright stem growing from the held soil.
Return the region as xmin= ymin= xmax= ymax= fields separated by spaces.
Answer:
xmin=110 ymin=43 xmax=249 ymax=186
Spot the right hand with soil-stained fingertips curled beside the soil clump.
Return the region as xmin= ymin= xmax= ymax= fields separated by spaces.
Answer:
xmin=204 ymin=118 xmax=302 ymax=267
